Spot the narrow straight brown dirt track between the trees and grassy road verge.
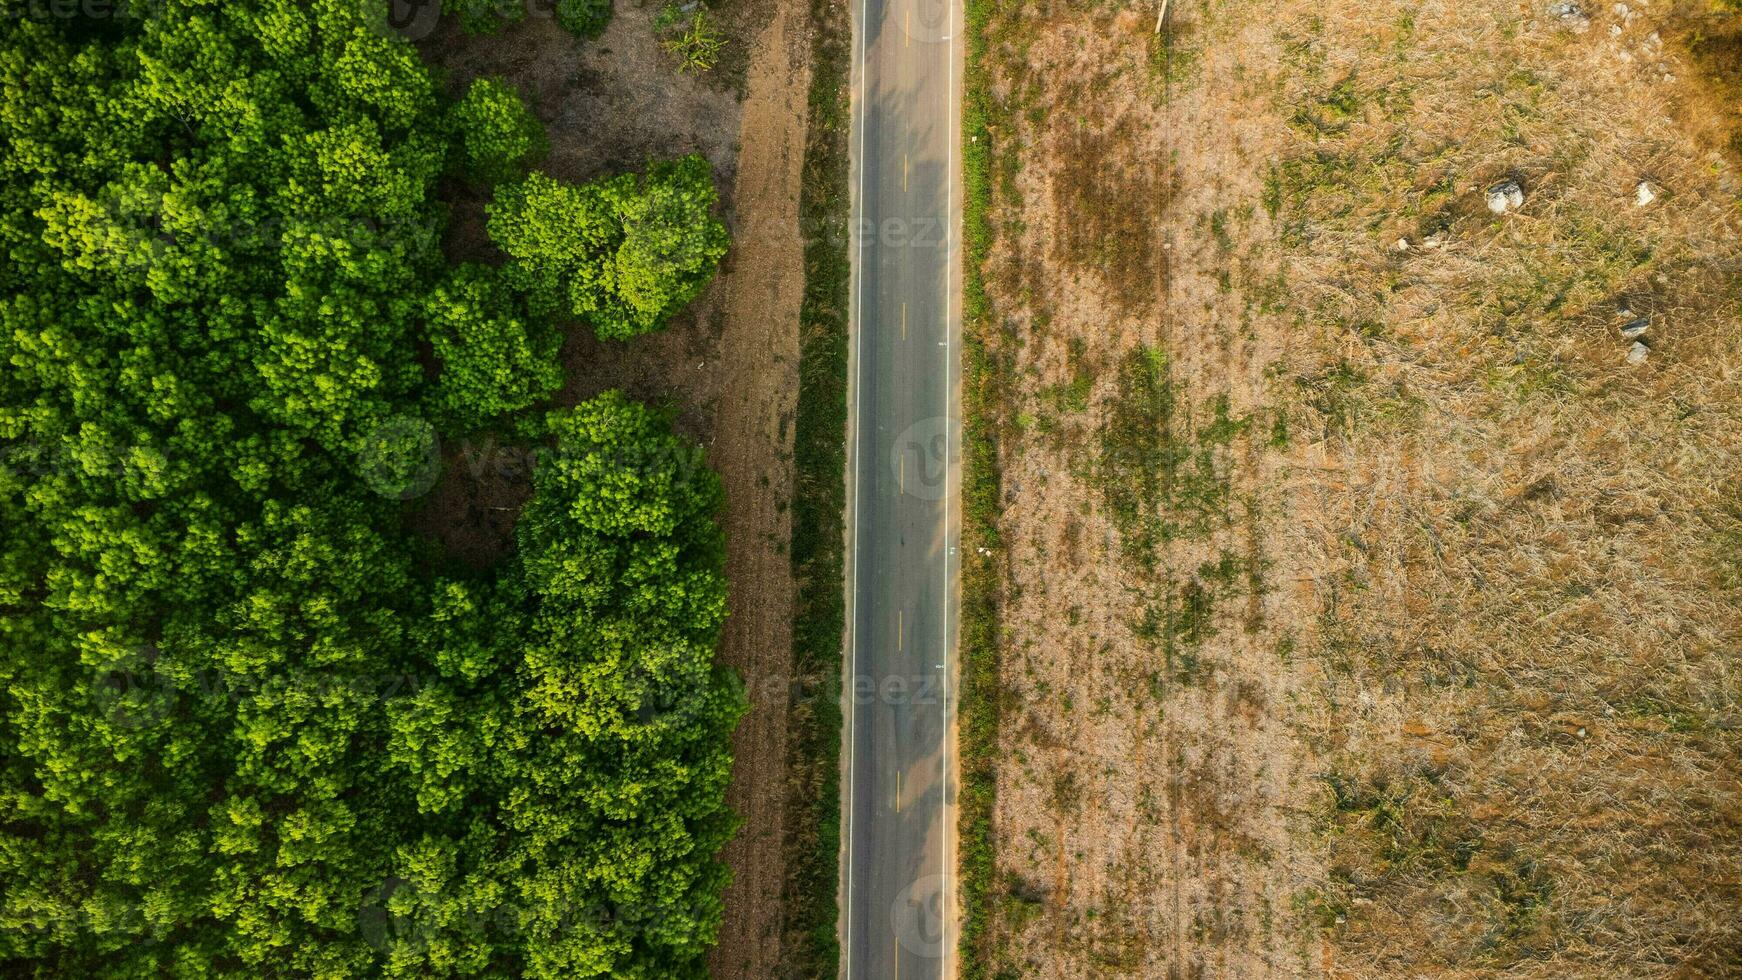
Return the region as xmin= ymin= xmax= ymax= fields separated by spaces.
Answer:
xmin=709 ymin=0 xmax=810 ymax=980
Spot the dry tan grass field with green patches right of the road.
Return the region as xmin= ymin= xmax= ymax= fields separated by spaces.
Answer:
xmin=970 ymin=0 xmax=1742 ymax=980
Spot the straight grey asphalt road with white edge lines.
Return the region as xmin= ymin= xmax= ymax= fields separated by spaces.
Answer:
xmin=841 ymin=0 xmax=962 ymax=980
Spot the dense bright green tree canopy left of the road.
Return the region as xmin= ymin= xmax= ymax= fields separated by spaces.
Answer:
xmin=0 ymin=0 xmax=744 ymax=980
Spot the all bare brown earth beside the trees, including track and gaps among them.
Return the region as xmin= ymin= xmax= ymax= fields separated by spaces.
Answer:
xmin=425 ymin=0 xmax=810 ymax=980
